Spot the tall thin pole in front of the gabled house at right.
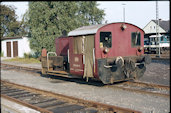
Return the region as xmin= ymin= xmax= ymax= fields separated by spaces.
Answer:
xmin=156 ymin=0 xmax=160 ymax=57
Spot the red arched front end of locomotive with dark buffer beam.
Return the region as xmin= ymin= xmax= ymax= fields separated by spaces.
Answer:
xmin=96 ymin=23 xmax=151 ymax=84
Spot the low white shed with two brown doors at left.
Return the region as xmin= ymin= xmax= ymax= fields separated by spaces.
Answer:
xmin=1 ymin=37 xmax=32 ymax=57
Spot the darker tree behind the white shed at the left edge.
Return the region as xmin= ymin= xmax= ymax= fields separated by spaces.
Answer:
xmin=0 ymin=4 xmax=28 ymax=37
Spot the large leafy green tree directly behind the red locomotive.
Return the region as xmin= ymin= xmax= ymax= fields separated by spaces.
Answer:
xmin=28 ymin=1 xmax=105 ymax=56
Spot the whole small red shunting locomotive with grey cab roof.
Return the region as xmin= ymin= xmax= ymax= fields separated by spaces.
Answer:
xmin=41 ymin=22 xmax=151 ymax=84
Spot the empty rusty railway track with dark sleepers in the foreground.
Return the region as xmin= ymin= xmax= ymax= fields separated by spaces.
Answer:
xmin=1 ymin=80 xmax=141 ymax=113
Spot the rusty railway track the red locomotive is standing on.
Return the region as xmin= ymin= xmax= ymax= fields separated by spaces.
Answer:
xmin=1 ymin=64 xmax=170 ymax=98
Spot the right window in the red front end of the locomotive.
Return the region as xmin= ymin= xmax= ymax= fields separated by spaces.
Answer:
xmin=131 ymin=32 xmax=141 ymax=47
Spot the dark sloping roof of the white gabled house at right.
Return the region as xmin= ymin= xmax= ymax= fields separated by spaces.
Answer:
xmin=152 ymin=19 xmax=170 ymax=32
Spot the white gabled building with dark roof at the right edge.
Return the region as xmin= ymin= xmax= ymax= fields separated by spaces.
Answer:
xmin=143 ymin=19 xmax=170 ymax=53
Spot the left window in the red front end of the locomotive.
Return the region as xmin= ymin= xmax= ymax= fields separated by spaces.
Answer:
xmin=100 ymin=32 xmax=112 ymax=48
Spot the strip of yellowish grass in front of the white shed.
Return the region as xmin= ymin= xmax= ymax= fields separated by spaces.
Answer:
xmin=4 ymin=58 xmax=40 ymax=64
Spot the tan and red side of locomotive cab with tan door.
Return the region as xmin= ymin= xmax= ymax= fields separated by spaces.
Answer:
xmin=69 ymin=35 xmax=94 ymax=78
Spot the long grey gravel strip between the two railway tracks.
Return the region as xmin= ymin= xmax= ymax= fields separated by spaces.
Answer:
xmin=1 ymin=70 xmax=170 ymax=113
